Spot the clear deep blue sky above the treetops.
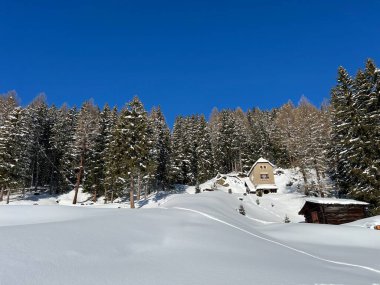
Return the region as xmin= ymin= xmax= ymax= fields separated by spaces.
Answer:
xmin=0 ymin=0 xmax=380 ymax=125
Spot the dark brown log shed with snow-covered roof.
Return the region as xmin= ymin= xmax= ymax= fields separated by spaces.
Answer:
xmin=298 ymin=198 xmax=368 ymax=225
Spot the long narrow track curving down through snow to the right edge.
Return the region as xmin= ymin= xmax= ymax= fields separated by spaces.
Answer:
xmin=174 ymin=207 xmax=380 ymax=274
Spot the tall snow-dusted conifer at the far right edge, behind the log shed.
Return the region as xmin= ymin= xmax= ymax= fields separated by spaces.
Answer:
xmin=347 ymin=60 xmax=380 ymax=211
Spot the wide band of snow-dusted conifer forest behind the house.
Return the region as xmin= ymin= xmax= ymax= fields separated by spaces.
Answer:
xmin=0 ymin=60 xmax=380 ymax=213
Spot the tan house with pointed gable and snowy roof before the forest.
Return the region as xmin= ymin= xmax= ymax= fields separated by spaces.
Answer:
xmin=246 ymin=158 xmax=277 ymax=194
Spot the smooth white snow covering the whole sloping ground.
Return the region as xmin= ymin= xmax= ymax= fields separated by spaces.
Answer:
xmin=0 ymin=168 xmax=380 ymax=285
